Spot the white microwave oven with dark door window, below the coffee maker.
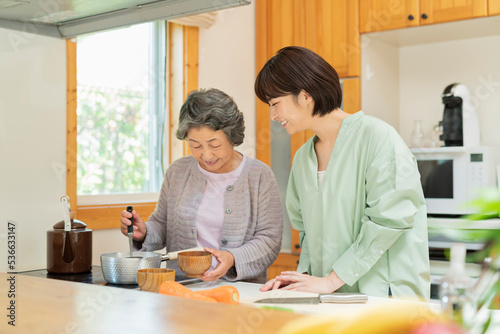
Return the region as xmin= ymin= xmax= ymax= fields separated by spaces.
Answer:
xmin=411 ymin=146 xmax=500 ymax=216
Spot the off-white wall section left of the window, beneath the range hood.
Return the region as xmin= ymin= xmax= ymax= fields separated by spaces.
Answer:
xmin=0 ymin=29 xmax=66 ymax=271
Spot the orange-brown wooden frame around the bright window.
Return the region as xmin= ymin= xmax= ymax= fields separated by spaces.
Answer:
xmin=66 ymin=22 xmax=199 ymax=230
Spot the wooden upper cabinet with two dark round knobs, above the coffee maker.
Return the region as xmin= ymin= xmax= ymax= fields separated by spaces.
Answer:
xmin=360 ymin=0 xmax=486 ymax=33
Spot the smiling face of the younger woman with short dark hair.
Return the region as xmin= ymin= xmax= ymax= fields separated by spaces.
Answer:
xmin=269 ymin=91 xmax=314 ymax=135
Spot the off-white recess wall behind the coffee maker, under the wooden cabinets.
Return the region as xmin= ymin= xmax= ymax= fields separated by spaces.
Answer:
xmin=399 ymin=36 xmax=500 ymax=146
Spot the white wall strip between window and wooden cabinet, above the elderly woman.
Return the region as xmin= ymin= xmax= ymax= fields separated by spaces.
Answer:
xmin=199 ymin=1 xmax=256 ymax=157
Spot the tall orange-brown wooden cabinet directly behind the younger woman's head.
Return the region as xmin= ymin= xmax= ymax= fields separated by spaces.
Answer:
xmin=255 ymin=0 xmax=361 ymax=165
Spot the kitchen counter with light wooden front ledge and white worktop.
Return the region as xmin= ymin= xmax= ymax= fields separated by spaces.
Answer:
xmin=0 ymin=273 xmax=500 ymax=334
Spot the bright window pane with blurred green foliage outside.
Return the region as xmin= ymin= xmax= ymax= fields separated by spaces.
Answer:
xmin=76 ymin=22 xmax=165 ymax=205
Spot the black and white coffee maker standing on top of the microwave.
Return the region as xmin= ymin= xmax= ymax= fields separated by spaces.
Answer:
xmin=439 ymin=83 xmax=480 ymax=147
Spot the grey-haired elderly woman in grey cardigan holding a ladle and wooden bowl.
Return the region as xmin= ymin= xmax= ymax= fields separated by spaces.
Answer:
xmin=121 ymin=89 xmax=283 ymax=282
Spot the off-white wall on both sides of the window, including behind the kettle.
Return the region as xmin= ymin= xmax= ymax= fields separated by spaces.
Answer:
xmin=0 ymin=4 xmax=255 ymax=271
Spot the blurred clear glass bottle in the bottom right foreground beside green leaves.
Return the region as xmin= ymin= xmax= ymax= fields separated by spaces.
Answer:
xmin=439 ymin=243 xmax=472 ymax=325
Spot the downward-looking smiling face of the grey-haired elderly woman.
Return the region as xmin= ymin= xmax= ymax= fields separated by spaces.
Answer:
xmin=186 ymin=126 xmax=241 ymax=173
